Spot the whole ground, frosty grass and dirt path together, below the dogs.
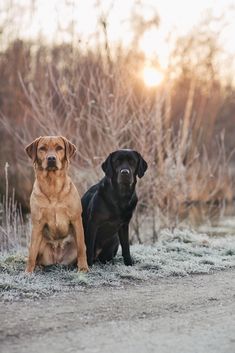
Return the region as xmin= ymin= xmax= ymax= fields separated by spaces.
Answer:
xmin=0 ymin=229 xmax=235 ymax=353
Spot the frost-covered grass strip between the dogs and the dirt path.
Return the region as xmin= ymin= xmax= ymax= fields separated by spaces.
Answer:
xmin=0 ymin=229 xmax=235 ymax=301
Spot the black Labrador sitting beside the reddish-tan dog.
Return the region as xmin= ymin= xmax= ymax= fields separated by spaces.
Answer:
xmin=82 ymin=150 xmax=148 ymax=266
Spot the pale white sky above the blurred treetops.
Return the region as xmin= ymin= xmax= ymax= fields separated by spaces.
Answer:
xmin=0 ymin=0 xmax=235 ymax=72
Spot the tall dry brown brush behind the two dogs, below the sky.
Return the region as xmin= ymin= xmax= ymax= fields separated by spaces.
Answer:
xmin=0 ymin=38 xmax=233 ymax=242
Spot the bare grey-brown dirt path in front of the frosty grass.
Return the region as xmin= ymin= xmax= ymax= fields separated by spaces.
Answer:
xmin=0 ymin=269 xmax=235 ymax=353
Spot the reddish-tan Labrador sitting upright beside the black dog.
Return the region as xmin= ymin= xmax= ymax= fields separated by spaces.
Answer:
xmin=26 ymin=136 xmax=88 ymax=272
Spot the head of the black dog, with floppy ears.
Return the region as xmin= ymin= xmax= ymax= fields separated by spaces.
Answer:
xmin=102 ymin=149 xmax=148 ymax=185
